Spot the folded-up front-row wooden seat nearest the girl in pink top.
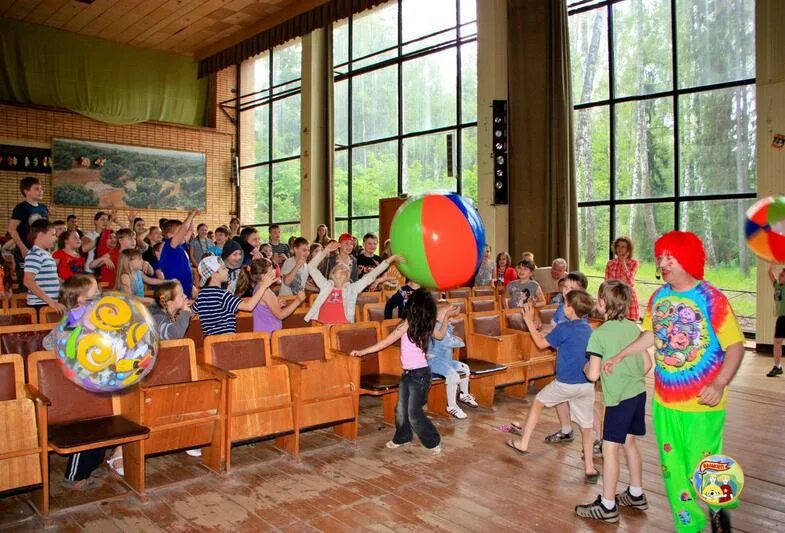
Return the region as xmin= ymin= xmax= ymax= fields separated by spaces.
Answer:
xmin=272 ymin=327 xmax=360 ymax=440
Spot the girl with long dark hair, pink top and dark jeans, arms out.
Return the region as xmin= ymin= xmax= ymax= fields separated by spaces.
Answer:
xmin=343 ymin=290 xmax=456 ymax=455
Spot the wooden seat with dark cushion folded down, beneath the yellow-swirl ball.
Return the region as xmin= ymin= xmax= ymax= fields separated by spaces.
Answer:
xmin=27 ymin=351 xmax=150 ymax=515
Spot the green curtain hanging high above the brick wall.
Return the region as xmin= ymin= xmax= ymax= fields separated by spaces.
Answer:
xmin=0 ymin=18 xmax=207 ymax=126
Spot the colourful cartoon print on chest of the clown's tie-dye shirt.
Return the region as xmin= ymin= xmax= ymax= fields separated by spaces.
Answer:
xmin=653 ymin=300 xmax=707 ymax=367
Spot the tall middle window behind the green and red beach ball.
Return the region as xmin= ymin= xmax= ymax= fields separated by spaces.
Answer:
xmin=333 ymin=0 xmax=477 ymax=235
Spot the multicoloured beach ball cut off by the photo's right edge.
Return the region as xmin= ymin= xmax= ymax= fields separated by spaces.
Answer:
xmin=744 ymin=196 xmax=785 ymax=263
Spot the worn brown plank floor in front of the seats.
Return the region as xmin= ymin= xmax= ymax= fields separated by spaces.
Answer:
xmin=0 ymin=353 xmax=785 ymax=533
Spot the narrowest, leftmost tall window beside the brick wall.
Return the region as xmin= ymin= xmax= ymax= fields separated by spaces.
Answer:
xmin=238 ymin=39 xmax=302 ymax=238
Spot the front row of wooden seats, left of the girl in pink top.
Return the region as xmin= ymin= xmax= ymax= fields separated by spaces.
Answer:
xmin=0 ymin=327 xmax=360 ymax=517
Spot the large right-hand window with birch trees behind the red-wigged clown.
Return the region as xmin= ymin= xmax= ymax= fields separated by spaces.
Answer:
xmin=569 ymin=0 xmax=756 ymax=327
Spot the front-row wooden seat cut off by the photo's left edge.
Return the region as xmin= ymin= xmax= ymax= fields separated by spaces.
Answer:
xmin=0 ymin=354 xmax=49 ymax=520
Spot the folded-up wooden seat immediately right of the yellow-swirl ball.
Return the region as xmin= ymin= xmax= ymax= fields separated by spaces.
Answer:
xmin=120 ymin=339 xmax=229 ymax=494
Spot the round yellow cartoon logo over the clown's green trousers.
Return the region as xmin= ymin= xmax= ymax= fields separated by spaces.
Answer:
xmin=692 ymin=455 xmax=744 ymax=507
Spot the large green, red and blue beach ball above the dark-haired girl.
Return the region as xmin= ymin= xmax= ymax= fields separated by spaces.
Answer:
xmin=390 ymin=193 xmax=485 ymax=290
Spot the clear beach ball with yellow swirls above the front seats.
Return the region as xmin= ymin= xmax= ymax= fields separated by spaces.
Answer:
xmin=53 ymin=292 xmax=158 ymax=392
